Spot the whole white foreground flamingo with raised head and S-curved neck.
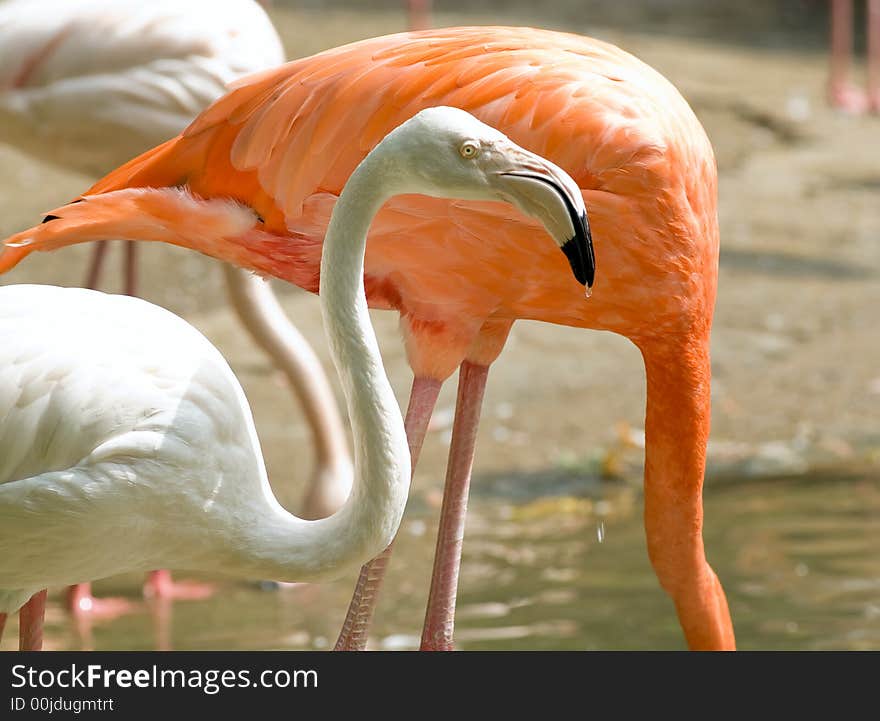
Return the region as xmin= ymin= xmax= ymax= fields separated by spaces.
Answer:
xmin=0 ymin=108 xmax=585 ymax=648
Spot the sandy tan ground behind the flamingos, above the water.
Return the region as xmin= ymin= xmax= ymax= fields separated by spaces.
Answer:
xmin=0 ymin=3 xmax=880 ymax=516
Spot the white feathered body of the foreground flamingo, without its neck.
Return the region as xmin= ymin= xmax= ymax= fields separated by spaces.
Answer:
xmin=0 ymin=285 xmax=305 ymax=612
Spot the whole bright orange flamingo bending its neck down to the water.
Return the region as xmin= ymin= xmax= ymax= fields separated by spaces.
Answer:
xmin=0 ymin=27 xmax=734 ymax=649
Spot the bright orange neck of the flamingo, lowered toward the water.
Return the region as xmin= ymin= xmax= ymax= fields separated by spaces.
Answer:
xmin=640 ymin=331 xmax=736 ymax=650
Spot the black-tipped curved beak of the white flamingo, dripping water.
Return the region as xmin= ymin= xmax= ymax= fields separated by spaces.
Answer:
xmin=499 ymin=151 xmax=596 ymax=288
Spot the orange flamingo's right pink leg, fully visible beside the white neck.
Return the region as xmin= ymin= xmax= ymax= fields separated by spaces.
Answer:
xmin=421 ymin=361 xmax=489 ymax=651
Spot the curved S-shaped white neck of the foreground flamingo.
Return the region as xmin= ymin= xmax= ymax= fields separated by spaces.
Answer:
xmin=230 ymin=151 xmax=410 ymax=581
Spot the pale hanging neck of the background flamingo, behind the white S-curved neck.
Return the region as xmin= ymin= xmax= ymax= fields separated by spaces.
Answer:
xmin=223 ymin=263 xmax=353 ymax=519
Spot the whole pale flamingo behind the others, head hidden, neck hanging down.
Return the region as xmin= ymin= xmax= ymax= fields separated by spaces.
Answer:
xmin=0 ymin=0 xmax=352 ymax=612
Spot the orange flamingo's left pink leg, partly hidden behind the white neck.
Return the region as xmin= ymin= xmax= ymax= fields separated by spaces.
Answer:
xmin=334 ymin=377 xmax=443 ymax=651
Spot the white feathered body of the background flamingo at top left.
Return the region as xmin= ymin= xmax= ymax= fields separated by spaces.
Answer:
xmin=0 ymin=0 xmax=285 ymax=175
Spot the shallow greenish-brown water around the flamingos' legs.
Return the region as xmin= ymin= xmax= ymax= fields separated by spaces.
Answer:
xmin=4 ymin=470 xmax=880 ymax=649
